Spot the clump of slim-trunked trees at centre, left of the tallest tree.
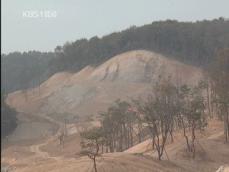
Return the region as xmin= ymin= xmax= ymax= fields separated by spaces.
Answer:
xmin=101 ymin=100 xmax=136 ymax=152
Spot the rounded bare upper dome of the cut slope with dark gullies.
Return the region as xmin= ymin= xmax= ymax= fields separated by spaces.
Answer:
xmin=90 ymin=50 xmax=199 ymax=83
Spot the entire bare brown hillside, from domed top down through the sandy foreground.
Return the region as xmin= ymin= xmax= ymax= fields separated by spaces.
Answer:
xmin=2 ymin=50 xmax=229 ymax=172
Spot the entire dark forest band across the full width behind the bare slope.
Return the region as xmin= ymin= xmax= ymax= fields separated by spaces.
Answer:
xmin=2 ymin=18 xmax=229 ymax=92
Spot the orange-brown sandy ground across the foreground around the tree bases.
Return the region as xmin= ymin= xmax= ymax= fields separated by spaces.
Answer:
xmin=2 ymin=120 xmax=229 ymax=172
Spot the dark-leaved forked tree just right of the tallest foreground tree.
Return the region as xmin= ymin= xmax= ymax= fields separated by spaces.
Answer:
xmin=178 ymin=84 xmax=207 ymax=158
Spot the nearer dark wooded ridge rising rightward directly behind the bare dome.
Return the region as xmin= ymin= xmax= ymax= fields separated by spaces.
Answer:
xmin=53 ymin=18 xmax=229 ymax=71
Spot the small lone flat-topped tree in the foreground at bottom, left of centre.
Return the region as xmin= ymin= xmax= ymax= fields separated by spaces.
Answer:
xmin=80 ymin=128 xmax=102 ymax=172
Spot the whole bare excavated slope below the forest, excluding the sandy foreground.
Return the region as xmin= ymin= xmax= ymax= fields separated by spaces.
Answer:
xmin=7 ymin=50 xmax=202 ymax=121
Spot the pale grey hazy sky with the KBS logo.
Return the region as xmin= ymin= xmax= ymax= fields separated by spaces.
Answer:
xmin=1 ymin=0 xmax=229 ymax=53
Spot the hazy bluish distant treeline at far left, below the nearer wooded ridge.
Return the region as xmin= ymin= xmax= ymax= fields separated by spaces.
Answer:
xmin=1 ymin=51 xmax=54 ymax=94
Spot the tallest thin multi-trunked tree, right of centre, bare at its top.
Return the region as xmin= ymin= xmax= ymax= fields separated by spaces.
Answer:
xmin=142 ymin=78 xmax=176 ymax=160
